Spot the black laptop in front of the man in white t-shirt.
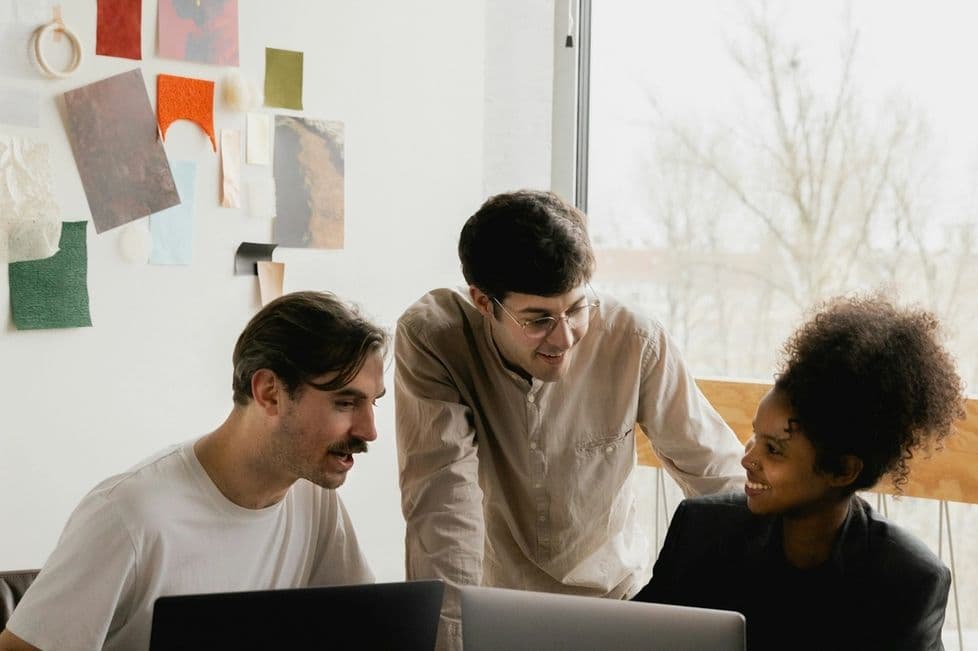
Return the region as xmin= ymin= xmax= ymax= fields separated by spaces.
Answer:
xmin=149 ymin=581 xmax=444 ymax=651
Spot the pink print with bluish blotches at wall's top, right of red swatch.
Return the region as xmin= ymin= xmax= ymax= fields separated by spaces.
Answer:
xmin=157 ymin=0 xmax=238 ymax=66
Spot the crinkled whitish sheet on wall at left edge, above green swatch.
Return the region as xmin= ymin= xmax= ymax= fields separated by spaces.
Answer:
xmin=0 ymin=134 xmax=61 ymax=263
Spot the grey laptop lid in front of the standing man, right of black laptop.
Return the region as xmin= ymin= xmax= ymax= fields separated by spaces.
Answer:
xmin=461 ymin=586 xmax=746 ymax=651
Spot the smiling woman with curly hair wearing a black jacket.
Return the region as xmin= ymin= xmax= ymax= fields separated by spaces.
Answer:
xmin=635 ymin=296 xmax=964 ymax=651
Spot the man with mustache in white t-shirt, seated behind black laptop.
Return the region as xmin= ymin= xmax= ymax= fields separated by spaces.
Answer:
xmin=0 ymin=292 xmax=387 ymax=651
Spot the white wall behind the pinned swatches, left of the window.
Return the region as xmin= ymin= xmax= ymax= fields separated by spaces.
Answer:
xmin=0 ymin=0 xmax=553 ymax=580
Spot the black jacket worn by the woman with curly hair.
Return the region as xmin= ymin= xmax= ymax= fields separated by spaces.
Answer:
xmin=634 ymin=493 xmax=951 ymax=651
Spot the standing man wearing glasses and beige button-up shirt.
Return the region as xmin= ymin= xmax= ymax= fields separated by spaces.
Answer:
xmin=395 ymin=191 xmax=744 ymax=649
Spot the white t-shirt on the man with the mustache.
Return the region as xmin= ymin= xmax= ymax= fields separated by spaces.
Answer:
xmin=7 ymin=441 xmax=374 ymax=651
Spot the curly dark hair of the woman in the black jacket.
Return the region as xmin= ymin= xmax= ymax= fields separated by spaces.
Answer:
xmin=775 ymin=295 xmax=964 ymax=492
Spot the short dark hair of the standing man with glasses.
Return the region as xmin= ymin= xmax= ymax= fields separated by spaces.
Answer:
xmin=458 ymin=190 xmax=595 ymax=300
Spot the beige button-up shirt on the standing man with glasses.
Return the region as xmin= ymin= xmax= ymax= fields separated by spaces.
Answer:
xmin=394 ymin=289 xmax=745 ymax=646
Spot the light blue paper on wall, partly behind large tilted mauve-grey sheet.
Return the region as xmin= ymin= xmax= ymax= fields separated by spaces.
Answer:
xmin=149 ymin=161 xmax=197 ymax=264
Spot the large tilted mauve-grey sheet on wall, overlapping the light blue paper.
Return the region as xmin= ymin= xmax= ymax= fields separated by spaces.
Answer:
xmin=64 ymin=68 xmax=180 ymax=233
